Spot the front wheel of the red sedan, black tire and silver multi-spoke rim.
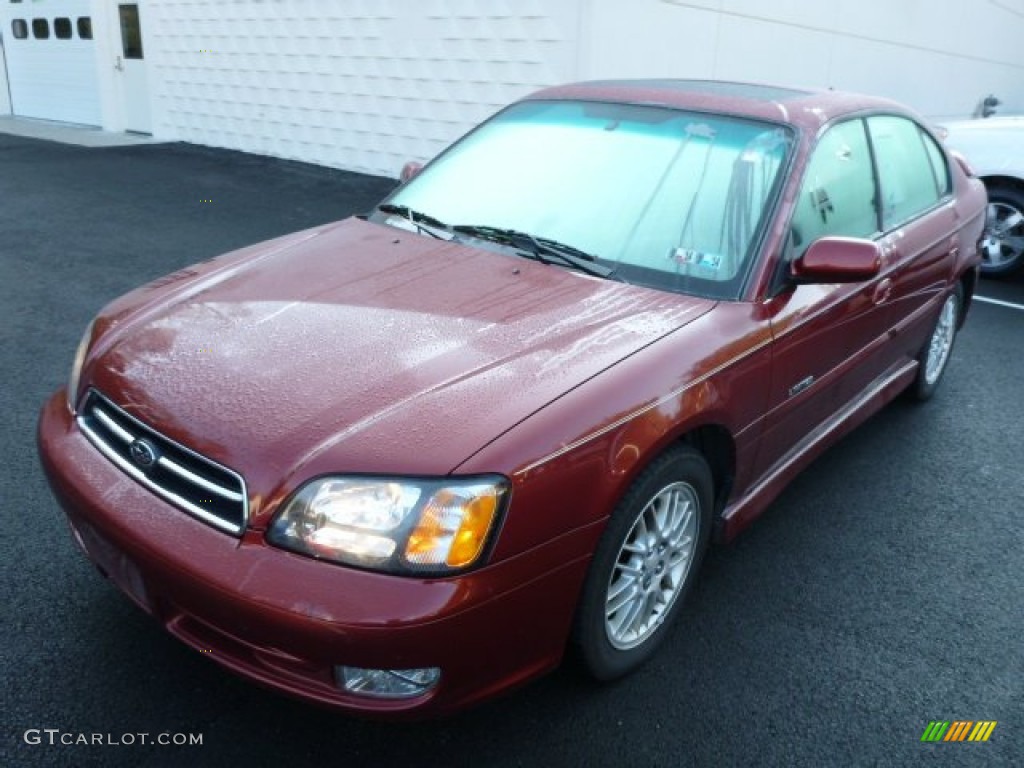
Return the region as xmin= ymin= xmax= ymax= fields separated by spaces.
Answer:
xmin=573 ymin=445 xmax=714 ymax=680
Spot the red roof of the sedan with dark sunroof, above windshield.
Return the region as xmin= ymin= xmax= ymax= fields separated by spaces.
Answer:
xmin=526 ymin=80 xmax=912 ymax=131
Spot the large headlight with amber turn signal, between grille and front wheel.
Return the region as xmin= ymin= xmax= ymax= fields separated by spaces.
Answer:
xmin=267 ymin=475 xmax=509 ymax=574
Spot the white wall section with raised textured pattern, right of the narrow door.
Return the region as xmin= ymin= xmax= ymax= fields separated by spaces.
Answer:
xmin=146 ymin=0 xmax=579 ymax=176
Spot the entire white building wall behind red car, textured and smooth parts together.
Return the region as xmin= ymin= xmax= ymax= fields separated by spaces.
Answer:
xmin=140 ymin=0 xmax=1024 ymax=176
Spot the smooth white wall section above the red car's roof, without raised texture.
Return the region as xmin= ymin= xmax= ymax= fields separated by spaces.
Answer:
xmin=583 ymin=0 xmax=1024 ymax=118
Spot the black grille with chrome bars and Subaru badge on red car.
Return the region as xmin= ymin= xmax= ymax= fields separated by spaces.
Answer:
xmin=77 ymin=389 xmax=249 ymax=536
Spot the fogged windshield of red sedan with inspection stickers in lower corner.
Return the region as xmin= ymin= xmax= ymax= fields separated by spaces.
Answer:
xmin=389 ymin=96 xmax=791 ymax=298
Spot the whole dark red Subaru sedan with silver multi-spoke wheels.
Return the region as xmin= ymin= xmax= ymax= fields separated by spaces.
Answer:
xmin=39 ymin=81 xmax=986 ymax=717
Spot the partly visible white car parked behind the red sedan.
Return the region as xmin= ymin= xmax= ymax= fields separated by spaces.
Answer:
xmin=940 ymin=115 xmax=1024 ymax=275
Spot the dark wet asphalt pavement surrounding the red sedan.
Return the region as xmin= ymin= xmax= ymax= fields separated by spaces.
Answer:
xmin=0 ymin=129 xmax=1024 ymax=768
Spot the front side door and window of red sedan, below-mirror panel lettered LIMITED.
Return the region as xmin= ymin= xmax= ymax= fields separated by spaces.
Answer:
xmin=758 ymin=119 xmax=890 ymax=481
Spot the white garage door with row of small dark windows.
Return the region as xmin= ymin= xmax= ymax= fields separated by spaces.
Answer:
xmin=0 ymin=0 xmax=101 ymax=125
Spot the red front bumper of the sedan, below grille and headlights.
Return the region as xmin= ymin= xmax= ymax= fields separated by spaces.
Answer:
xmin=38 ymin=391 xmax=595 ymax=717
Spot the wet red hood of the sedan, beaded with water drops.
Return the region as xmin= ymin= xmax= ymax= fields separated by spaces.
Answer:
xmin=85 ymin=219 xmax=713 ymax=520
